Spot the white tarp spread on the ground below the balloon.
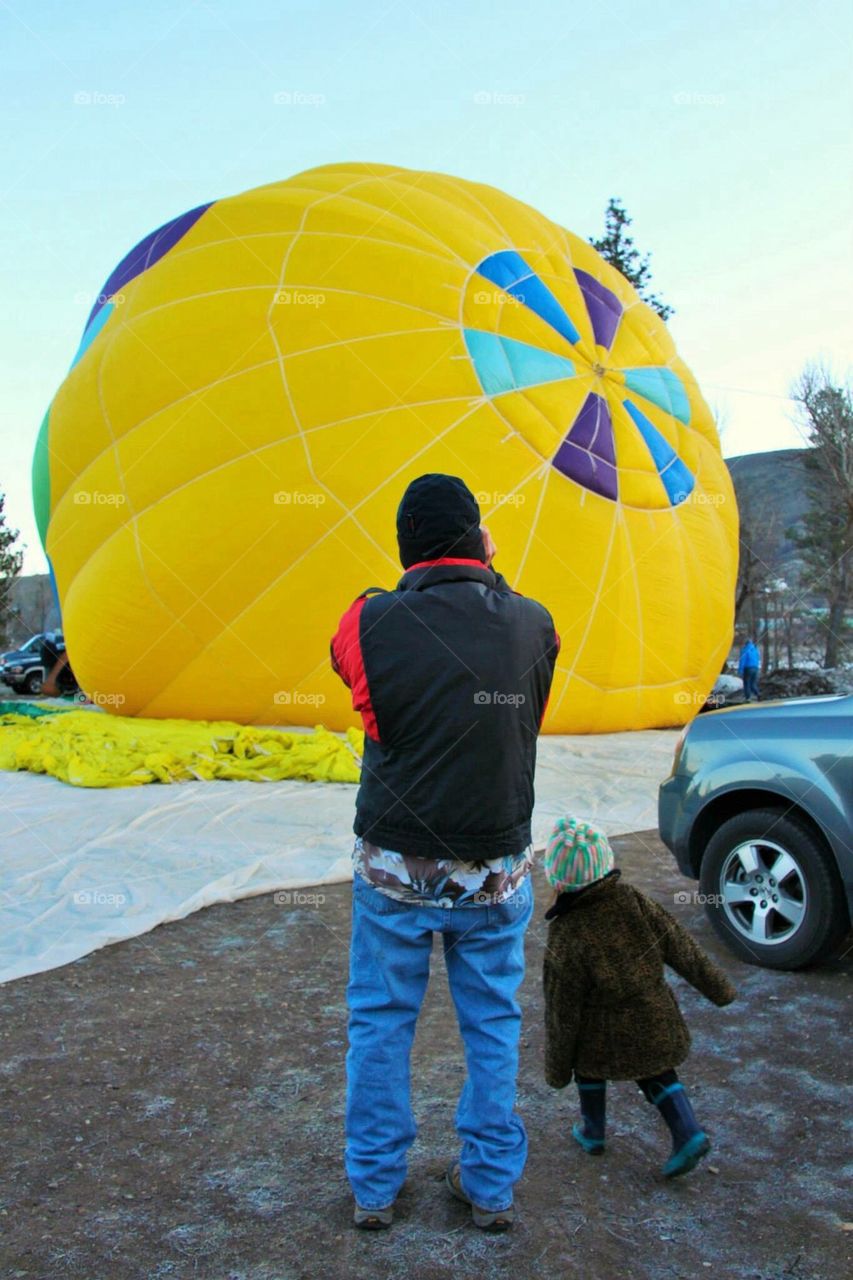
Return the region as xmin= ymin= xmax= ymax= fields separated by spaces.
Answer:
xmin=0 ymin=730 xmax=678 ymax=982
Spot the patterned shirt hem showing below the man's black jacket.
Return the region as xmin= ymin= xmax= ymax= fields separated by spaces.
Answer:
xmin=352 ymin=836 xmax=533 ymax=906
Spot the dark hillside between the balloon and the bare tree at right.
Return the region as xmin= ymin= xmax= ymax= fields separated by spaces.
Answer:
xmin=726 ymin=449 xmax=808 ymax=567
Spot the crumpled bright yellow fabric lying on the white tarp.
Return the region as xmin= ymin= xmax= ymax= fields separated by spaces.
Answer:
xmin=0 ymin=710 xmax=364 ymax=787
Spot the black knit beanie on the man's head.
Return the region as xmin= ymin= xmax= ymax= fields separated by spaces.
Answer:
xmin=397 ymin=474 xmax=485 ymax=568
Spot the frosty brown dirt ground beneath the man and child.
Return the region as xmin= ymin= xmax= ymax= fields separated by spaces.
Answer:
xmin=0 ymin=832 xmax=853 ymax=1280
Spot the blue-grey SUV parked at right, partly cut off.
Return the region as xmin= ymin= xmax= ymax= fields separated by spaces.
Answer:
xmin=658 ymin=696 xmax=853 ymax=969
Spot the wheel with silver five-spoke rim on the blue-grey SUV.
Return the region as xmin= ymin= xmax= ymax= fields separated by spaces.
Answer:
xmin=699 ymin=809 xmax=849 ymax=969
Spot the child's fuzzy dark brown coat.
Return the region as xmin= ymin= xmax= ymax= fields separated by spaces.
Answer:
xmin=543 ymin=874 xmax=736 ymax=1089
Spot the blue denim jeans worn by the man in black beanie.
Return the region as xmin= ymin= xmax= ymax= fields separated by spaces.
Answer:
xmin=346 ymin=876 xmax=533 ymax=1212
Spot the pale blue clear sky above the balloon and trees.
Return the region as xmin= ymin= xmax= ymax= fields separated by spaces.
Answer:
xmin=0 ymin=0 xmax=853 ymax=572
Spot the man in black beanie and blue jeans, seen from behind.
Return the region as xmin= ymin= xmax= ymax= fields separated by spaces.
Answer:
xmin=332 ymin=475 xmax=560 ymax=1230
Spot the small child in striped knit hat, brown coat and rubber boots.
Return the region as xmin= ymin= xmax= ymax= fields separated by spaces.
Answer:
xmin=543 ymin=818 xmax=736 ymax=1178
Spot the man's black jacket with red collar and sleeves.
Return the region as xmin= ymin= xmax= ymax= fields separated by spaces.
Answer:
xmin=326 ymin=558 xmax=560 ymax=861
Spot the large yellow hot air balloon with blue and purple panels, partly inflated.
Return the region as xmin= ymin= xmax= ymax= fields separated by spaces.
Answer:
xmin=33 ymin=164 xmax=738 ymax=732
